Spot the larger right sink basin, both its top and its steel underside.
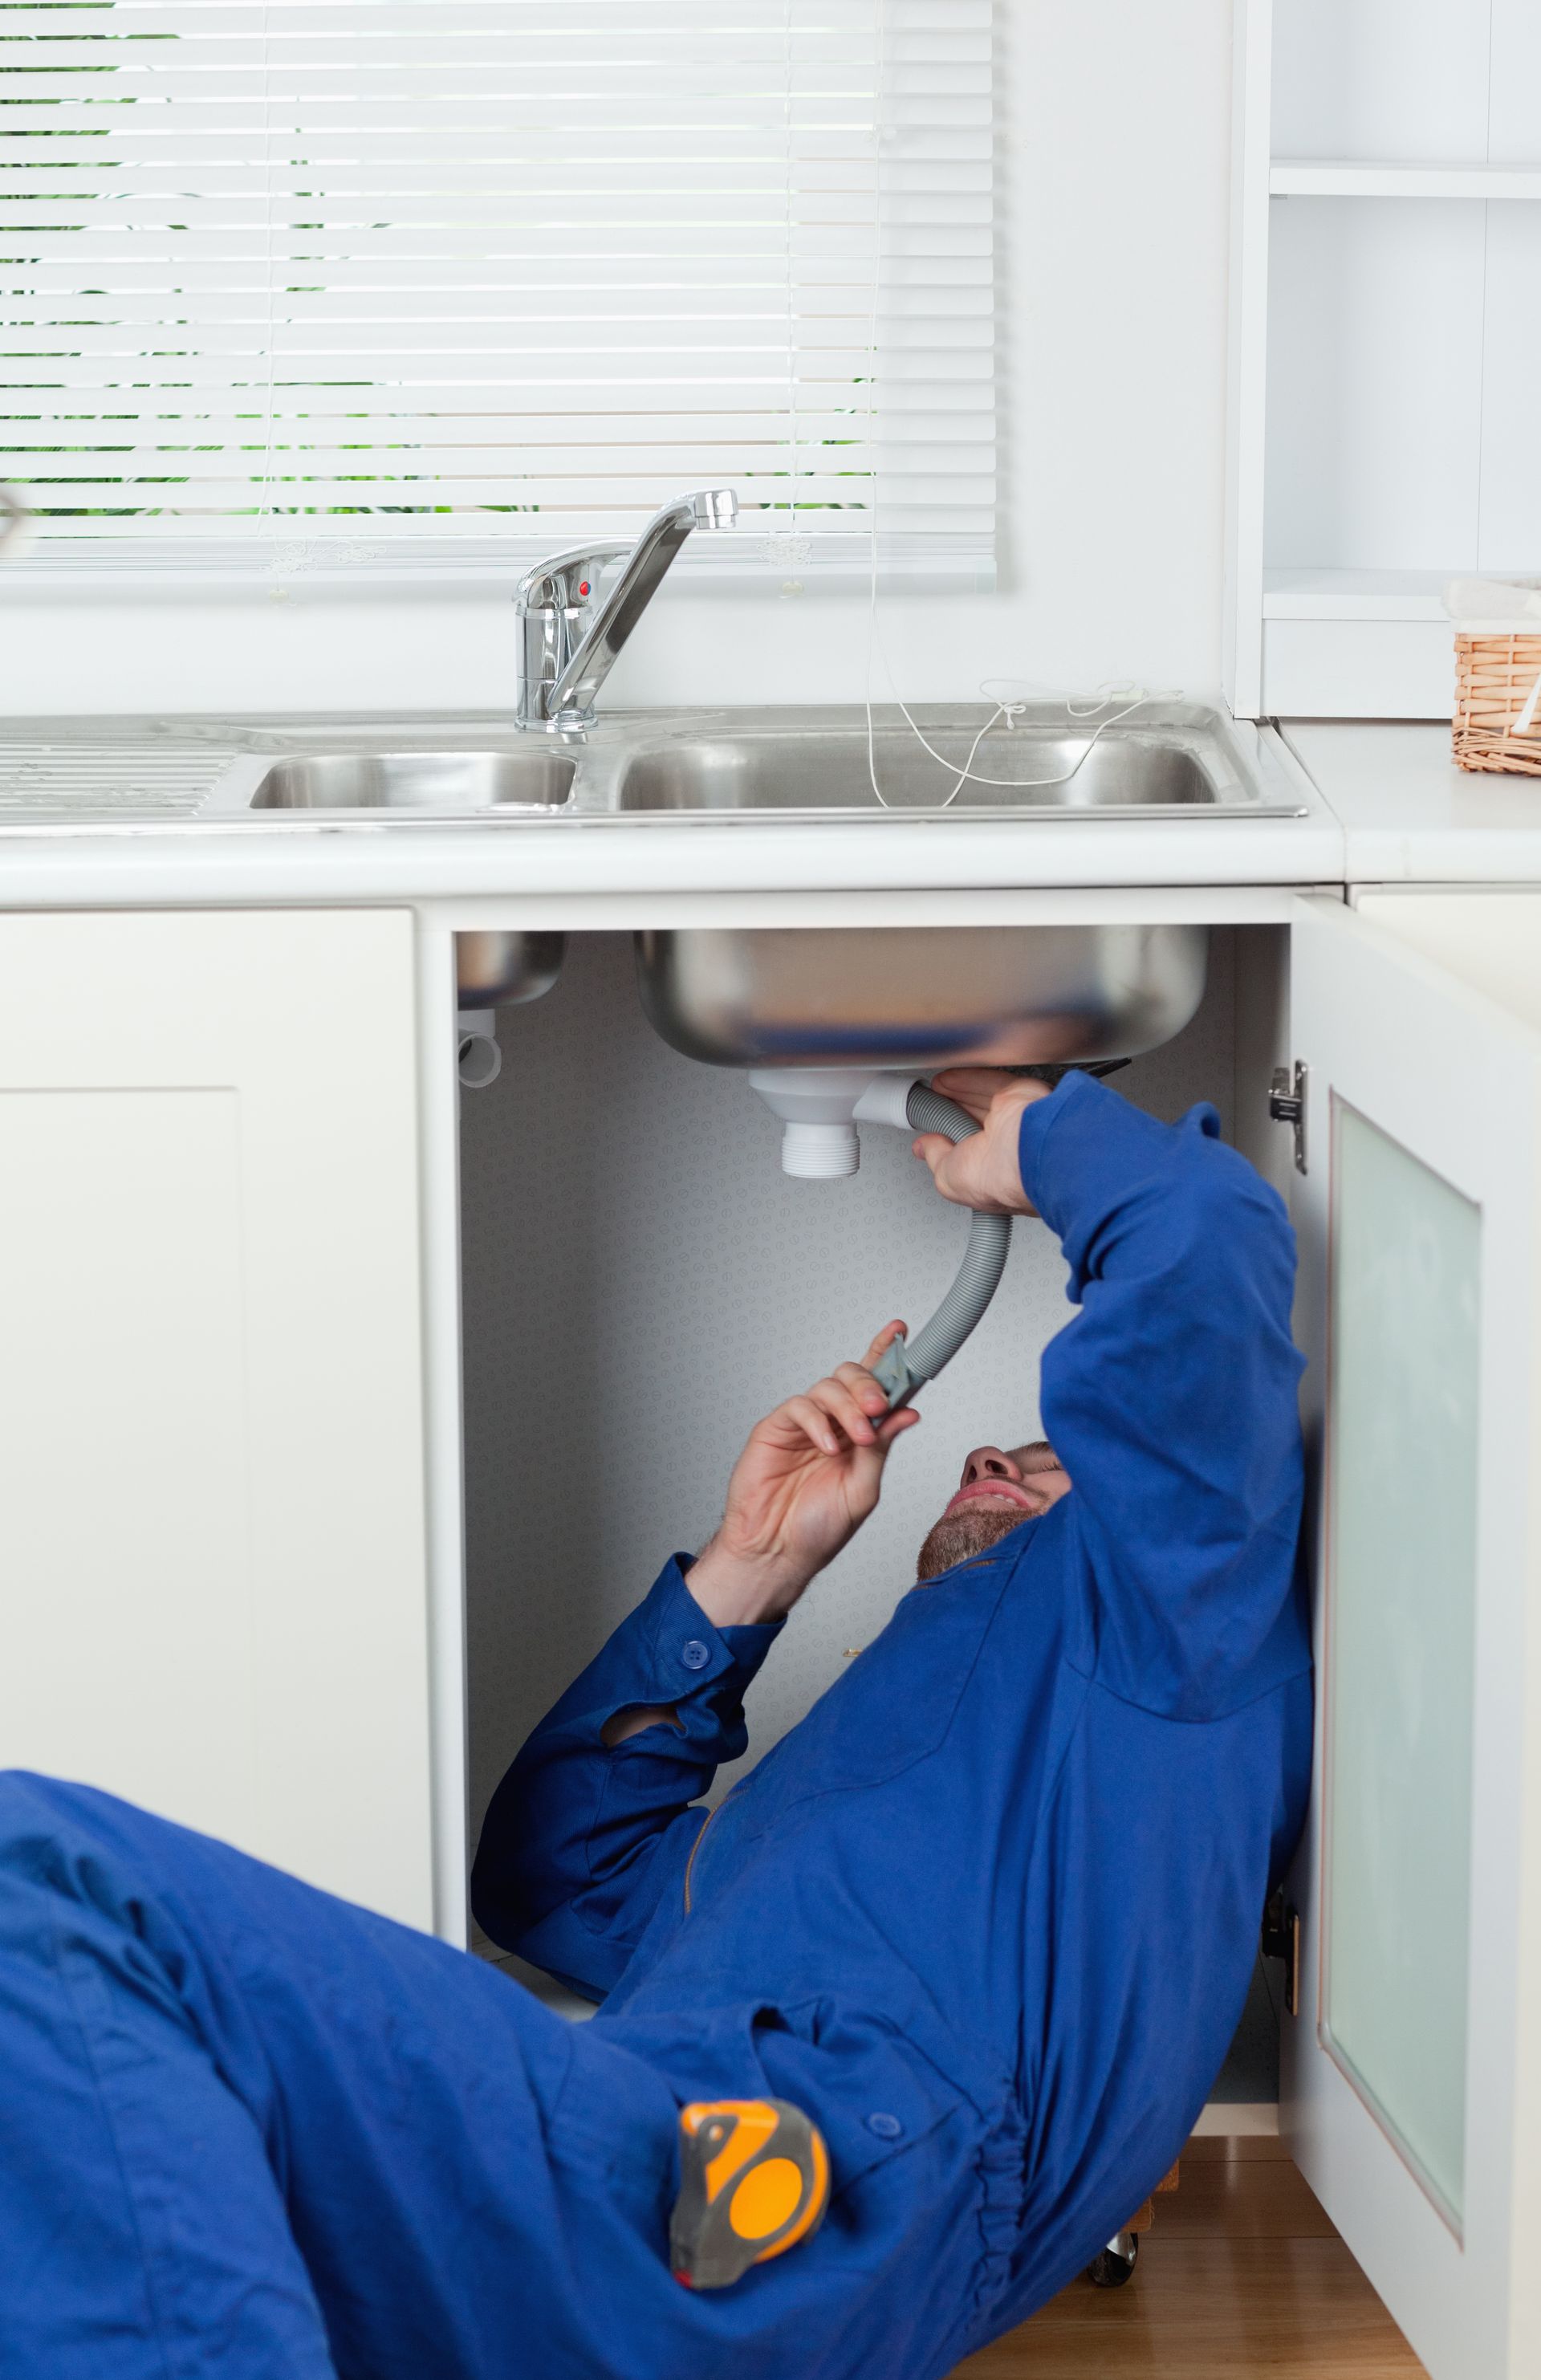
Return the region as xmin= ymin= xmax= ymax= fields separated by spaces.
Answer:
xmin=616 ymin=705 xmax=1236 ymax=1068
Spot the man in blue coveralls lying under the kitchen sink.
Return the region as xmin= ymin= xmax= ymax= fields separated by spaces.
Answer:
xmin=0 ymin=1071 xmax=1311 ymax=2380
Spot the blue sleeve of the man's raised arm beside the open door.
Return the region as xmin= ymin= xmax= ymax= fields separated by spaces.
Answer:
xmin=1018 ymin=1073 xmax=1301 ymax=1719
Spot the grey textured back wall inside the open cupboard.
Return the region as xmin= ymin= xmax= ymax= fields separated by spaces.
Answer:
xmin=461 ymin=933 xmax=1234 ymax=1830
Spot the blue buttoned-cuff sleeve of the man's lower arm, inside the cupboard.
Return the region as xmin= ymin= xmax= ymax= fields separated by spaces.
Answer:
xmin=471 ymin=1554 xmax=780 ymax=2000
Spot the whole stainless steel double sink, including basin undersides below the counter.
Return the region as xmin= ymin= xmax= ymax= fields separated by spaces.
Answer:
xmin=0 ymin=700 xmax=1306 ymax=1068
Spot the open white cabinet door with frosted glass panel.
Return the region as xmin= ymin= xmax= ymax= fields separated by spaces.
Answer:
xmin=1282 ymin=900 xmax=1541 ymax=2380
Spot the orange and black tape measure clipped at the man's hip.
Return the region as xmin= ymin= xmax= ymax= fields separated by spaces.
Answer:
xmin=669 ymin=2099 xmax=830 ymax=2289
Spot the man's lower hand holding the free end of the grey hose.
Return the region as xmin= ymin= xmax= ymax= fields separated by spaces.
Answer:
xmin=689 ymin=1324 xmax=921 ymax=1628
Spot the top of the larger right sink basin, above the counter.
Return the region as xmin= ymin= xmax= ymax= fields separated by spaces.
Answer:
xmin=616 ymin=702 xmax=1262 ymax=816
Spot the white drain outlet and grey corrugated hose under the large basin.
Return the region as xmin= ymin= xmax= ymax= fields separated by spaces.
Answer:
xmin=749 ymin=1066 xmax=1010 ymax=1411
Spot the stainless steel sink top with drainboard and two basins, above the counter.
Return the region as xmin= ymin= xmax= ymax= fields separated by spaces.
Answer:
xmin=0 ymin=700 xmax=1306 ymax=836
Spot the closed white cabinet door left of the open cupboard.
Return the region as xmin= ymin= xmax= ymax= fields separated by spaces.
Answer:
xmin=0 ymin=912 xmax=430 ymax=1926
